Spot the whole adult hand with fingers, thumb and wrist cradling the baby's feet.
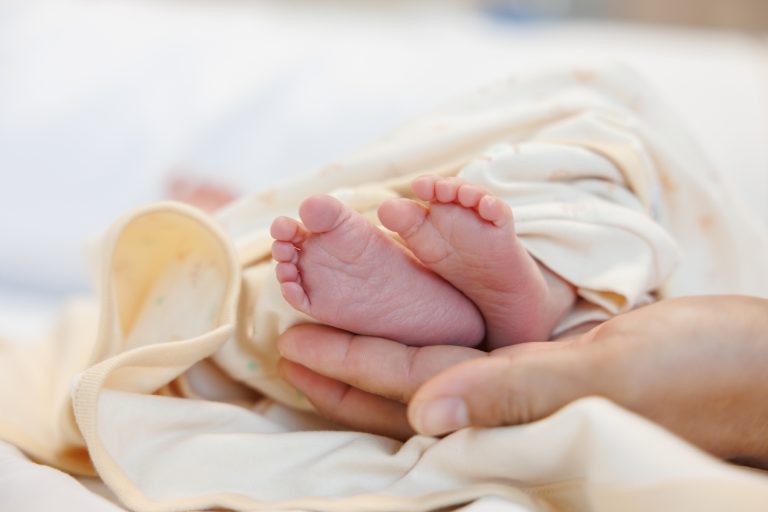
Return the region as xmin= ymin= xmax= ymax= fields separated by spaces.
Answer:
xmin=278 ymin=296 xmax=768 ymax=467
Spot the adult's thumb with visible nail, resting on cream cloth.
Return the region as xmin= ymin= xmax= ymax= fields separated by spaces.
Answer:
xmin=408 ymin=342 xmax=610 ymax=435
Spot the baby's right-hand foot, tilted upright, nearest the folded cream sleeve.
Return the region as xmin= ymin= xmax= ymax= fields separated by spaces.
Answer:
xmin=379 ymin=176 xmax=559 ymax=349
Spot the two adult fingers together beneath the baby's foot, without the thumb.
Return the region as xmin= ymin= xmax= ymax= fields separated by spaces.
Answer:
xmin=278 ymin=324 xmax=480 ymax=439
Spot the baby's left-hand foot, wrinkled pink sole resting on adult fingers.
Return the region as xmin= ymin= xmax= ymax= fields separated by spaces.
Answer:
xmin=271 ymin=196 xmax=484 ymax=345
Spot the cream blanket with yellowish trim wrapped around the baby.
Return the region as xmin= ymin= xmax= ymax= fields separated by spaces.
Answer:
xmin=0 ymin=68 xmax=768 ymax=511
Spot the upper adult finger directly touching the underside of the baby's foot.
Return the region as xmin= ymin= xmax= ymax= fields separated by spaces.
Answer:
xmin=277 ymin=324 xmax=486 ymax=402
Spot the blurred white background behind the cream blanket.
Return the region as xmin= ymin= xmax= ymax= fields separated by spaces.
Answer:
xmin=0 ymin=0 xmax=768 ymax=334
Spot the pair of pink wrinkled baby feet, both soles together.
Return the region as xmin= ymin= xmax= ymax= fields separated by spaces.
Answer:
xmin=271 ymin=176 xmax=575 ymax=348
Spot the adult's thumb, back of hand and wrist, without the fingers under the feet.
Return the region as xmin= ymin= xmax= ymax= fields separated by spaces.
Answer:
xmin=408 ymin=297 xmax=768 ymax=467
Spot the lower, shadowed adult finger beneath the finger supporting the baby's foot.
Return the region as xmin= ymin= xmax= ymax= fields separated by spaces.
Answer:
xmin=278 ymin=359 xmax=413 ymax=440
